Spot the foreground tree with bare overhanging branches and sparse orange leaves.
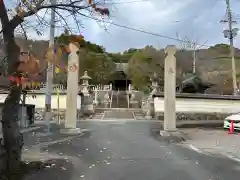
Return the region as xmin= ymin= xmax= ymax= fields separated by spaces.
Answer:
xmin=0 ymin=0 xmax=109 ymax=179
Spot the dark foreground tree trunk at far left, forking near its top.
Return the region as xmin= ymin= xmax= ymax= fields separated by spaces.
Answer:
xmin=0 ymin=0 xmax=23 ymax=177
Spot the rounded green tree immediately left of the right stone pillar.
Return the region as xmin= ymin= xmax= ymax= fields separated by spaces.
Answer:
xmin=128 ymin=46 xmax=164 ymax=91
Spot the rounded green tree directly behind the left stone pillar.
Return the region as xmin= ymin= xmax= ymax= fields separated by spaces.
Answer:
xmin=55 ymin=33 xmax=115 ymax=84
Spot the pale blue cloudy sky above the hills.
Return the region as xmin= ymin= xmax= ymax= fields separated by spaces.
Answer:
xmin=3 ymin=0 xmax=240 ymax=52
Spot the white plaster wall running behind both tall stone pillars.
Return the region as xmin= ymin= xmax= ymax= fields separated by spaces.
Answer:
xmin=0 ymin=94 xmax=240 ymax=113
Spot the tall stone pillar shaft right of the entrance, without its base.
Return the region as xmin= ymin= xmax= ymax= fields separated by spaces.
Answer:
xmin=164 ymin=46 xmax=176 ymax=131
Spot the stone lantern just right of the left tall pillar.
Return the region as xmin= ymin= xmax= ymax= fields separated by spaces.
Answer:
xmin=80 ymin=71 xmax=94 ymax=115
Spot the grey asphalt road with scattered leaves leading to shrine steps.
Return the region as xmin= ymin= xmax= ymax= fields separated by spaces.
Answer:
xmin=23 ymin=122 xmax=240 ymax=180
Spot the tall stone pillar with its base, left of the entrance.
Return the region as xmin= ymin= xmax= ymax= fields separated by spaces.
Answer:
xmin=61 ymin=43 xmax=80 ymax=134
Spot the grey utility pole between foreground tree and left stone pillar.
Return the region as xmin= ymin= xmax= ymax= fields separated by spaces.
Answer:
xmin=45 ymin=0 xmax=56 ymax=132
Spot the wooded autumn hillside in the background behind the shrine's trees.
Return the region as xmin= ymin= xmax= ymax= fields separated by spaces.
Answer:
xmin=0 ymin=38 xmax=240 ymax=93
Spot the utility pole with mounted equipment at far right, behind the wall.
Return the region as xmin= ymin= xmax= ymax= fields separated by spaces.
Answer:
xmin=221 ymin=0 xmax=238 ymax=95
